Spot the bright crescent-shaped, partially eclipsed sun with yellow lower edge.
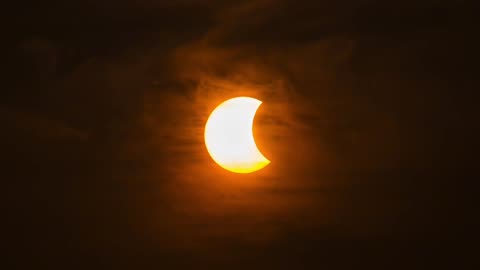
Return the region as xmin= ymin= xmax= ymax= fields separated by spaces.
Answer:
xmin=205 ymin=97 xmax=270 ymax=173
